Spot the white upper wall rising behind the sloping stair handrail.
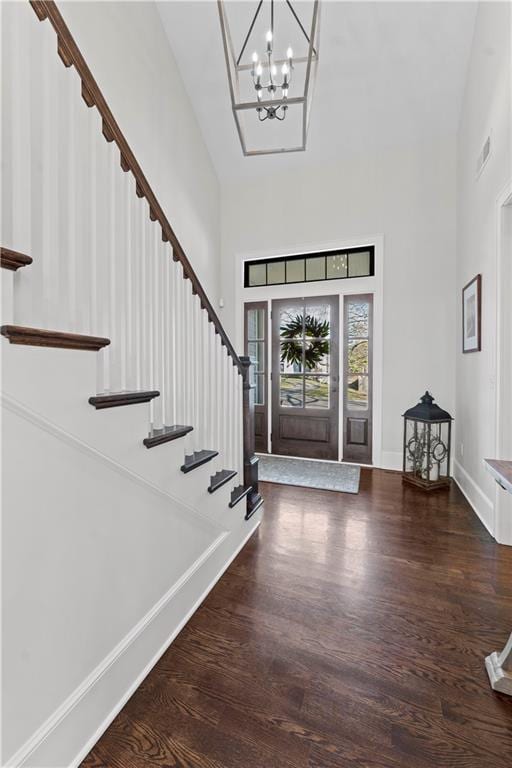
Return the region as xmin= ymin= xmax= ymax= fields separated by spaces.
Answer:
xmin=59 ymin=2 xmax=220 ymax=303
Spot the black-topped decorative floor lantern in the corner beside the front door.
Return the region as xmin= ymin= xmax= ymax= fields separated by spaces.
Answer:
xmin=402 ymin=392 xmax=452 ymax=491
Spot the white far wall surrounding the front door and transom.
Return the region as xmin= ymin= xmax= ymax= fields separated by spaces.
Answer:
xmin=221 ymin=138 xmax=455 ymax=468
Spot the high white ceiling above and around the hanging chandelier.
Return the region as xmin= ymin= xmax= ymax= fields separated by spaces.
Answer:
xmin=158 ymin=0 xmax=476 ymax=181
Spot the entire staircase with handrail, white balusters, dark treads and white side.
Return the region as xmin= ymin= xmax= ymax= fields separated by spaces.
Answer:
xmin=1 ymin=1 xmax=263 ymax=767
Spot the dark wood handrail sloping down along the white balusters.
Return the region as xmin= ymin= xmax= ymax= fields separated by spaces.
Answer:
xmin=30 ymin=0 xmax=243 ymax=375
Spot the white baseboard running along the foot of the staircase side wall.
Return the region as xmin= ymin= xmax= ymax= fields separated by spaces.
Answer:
xmin=8 ymin=514 xmax=261 ymax=768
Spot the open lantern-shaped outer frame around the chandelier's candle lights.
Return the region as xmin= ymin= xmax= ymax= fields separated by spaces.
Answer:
xmin=217 ymin=0 xmax=320 ymax=157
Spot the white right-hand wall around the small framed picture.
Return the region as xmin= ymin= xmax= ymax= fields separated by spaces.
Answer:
xmin=455 ymin=2 xmax=512 ymax=543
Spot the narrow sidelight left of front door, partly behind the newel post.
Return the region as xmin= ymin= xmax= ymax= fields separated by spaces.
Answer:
xmin=244 ymin=301 xmax=268 ymax=453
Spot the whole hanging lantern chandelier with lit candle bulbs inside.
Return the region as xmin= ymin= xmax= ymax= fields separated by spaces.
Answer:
xmin=218 ymin=0 xmax=319 ymax=156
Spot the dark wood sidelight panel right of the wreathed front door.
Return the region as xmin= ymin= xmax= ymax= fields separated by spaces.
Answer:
xmin=343 ymin=294 xmax=373 ymax=464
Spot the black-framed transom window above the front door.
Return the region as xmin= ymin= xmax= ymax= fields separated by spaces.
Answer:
xmin=244 ymin=245 xmax=375 ymax=288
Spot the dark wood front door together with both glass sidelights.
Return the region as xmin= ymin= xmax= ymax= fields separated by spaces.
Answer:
xmin=244 ymin=294 xmax=373 ymax=464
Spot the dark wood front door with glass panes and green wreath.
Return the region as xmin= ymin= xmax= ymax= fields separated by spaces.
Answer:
xmin=272 ymin=296 xmax=339 ymax=460
